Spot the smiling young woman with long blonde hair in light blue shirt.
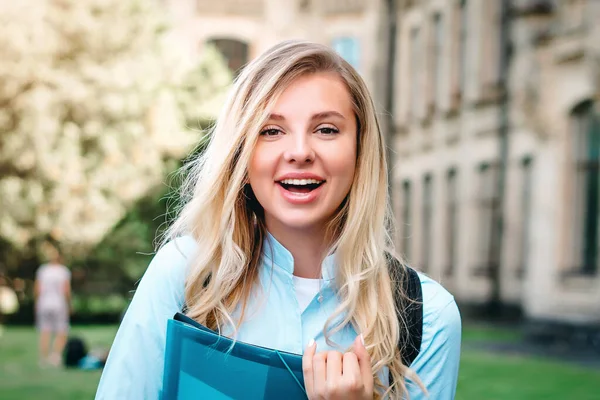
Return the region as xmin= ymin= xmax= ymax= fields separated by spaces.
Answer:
xmin=96 ymin=42 xmax=461 ymax=400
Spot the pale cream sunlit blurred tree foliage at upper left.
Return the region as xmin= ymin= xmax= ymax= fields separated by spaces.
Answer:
xmin=0 ymin=0 xmax=231 ymax=256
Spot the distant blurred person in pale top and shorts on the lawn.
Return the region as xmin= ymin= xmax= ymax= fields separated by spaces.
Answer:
xmin=34 ymin=254 xmax=71 ymax=366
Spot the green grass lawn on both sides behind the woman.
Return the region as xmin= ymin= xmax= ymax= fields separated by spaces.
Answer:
xmin=0 ymin=327 xmax=600 ymax=400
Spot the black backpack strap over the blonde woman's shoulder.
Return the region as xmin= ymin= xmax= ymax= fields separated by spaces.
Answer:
xmin=388 ymin=255 xmax=423 ymax=366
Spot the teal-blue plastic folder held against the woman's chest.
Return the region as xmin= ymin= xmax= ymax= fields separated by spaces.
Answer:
xmin=161 ymin=313 xmax=306 ymax=400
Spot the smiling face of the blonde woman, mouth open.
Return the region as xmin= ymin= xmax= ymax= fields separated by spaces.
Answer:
xmin=248 ymin=73 xmax=357 ymax=232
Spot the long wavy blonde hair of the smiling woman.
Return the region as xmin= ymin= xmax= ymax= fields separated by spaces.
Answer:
xmin=167 ymin=41 xmax=422 ymax=398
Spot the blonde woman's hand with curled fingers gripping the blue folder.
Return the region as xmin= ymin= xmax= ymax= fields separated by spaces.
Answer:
xmin=302 ymin=336 xmax=373 ymax=400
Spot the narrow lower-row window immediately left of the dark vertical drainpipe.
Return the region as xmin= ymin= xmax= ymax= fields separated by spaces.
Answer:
xmin=476 ymin=164 xmax=498 ymax=275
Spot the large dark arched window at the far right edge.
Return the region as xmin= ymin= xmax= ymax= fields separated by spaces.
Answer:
xmin=571 ymin=101 xmax=600 ymax=274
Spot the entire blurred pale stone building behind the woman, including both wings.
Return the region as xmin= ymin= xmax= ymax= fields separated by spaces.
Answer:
xmin=168 ymin=0 xmax=600 ymax=323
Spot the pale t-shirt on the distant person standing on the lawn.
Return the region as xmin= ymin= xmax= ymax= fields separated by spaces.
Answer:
xmin=36 ymin=264 xmax=71 ymax=310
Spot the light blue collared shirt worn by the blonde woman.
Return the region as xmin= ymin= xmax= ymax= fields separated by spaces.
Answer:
xmin=96 ymin=235 xmax=461 ymax=400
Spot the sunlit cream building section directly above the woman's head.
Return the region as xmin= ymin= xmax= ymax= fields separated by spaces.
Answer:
xmin=165 ymin=0 xmax=382 ymax=95
